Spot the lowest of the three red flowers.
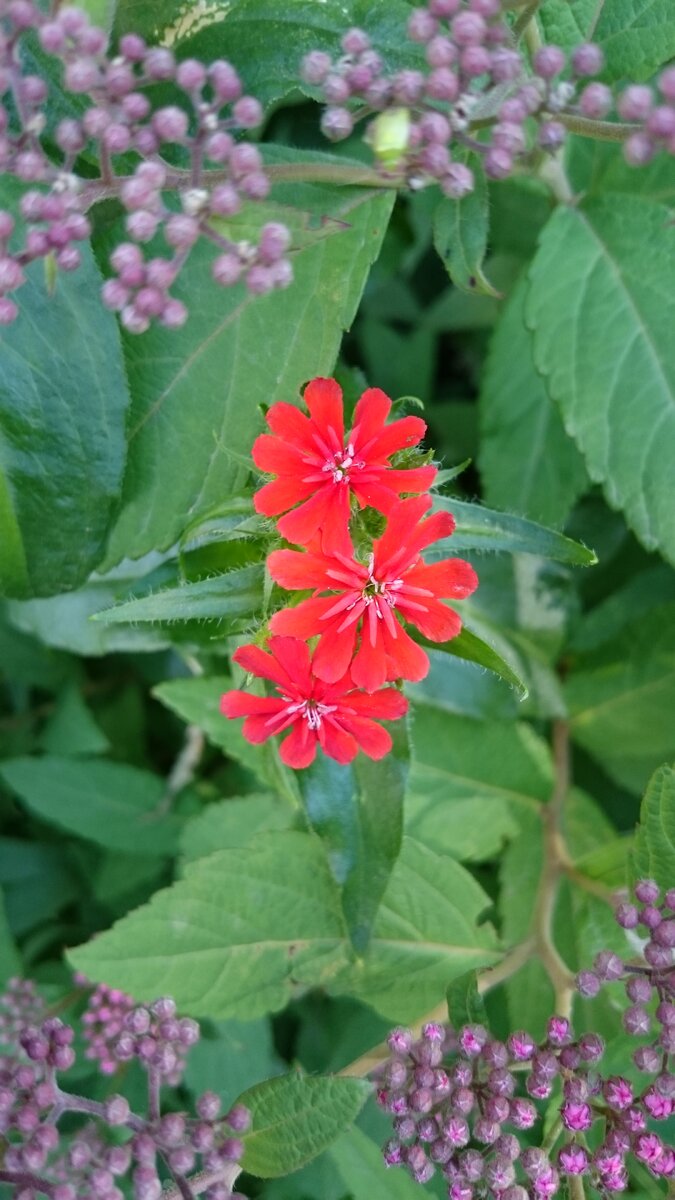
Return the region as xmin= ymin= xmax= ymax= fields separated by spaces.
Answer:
xmin=220 ymin=637 xmax=407 ymax=768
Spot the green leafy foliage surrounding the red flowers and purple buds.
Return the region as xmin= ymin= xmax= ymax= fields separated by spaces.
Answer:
xmin=0 ymin=0 xmax=675 ymax=1200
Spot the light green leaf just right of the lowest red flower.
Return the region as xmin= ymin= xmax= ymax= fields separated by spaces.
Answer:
xmin=406 ymin=704 xmax=552 ymax=862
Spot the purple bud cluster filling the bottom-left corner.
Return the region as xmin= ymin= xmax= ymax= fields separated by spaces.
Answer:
xmin=0 ymin=978 xmax=251 ymax=1200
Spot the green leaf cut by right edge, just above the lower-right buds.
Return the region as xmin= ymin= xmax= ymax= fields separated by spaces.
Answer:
xmin=631 ymin=764 xmax=675 ymax=890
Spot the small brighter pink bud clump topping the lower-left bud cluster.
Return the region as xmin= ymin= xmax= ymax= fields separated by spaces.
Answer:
xmin=82 ymin=984 xmax=199 ymax=1087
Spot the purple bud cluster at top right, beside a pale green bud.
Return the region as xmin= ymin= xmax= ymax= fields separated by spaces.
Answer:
xmin=301 ymin=0 xmax=675 ymax=192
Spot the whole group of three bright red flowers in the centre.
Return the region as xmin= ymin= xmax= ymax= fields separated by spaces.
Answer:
xmin=221 ymin=379 xmax=478 ymax=768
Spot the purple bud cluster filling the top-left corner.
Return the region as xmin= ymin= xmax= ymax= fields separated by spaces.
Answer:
xmin=0 ymin=0 xmax=293 ymax=332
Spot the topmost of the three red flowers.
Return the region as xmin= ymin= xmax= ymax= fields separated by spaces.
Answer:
xmin=252 ymin=379 xmax=436 ymax=553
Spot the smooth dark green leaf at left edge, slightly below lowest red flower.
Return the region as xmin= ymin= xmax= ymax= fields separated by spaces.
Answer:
xmin=0 ymin=755 xmax=183 ymax=856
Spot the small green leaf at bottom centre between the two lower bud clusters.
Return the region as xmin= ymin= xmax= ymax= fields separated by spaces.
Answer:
xmin=239 ymin=1073 xmax=372 ymax=1180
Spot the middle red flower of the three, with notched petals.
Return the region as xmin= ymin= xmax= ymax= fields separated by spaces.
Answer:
xmin=268 ymin=496 xmax=478 ymax=691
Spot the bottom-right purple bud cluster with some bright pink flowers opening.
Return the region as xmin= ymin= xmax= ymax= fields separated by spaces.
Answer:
xmin=377 ymin=880 xmax=675 ymax=1200
